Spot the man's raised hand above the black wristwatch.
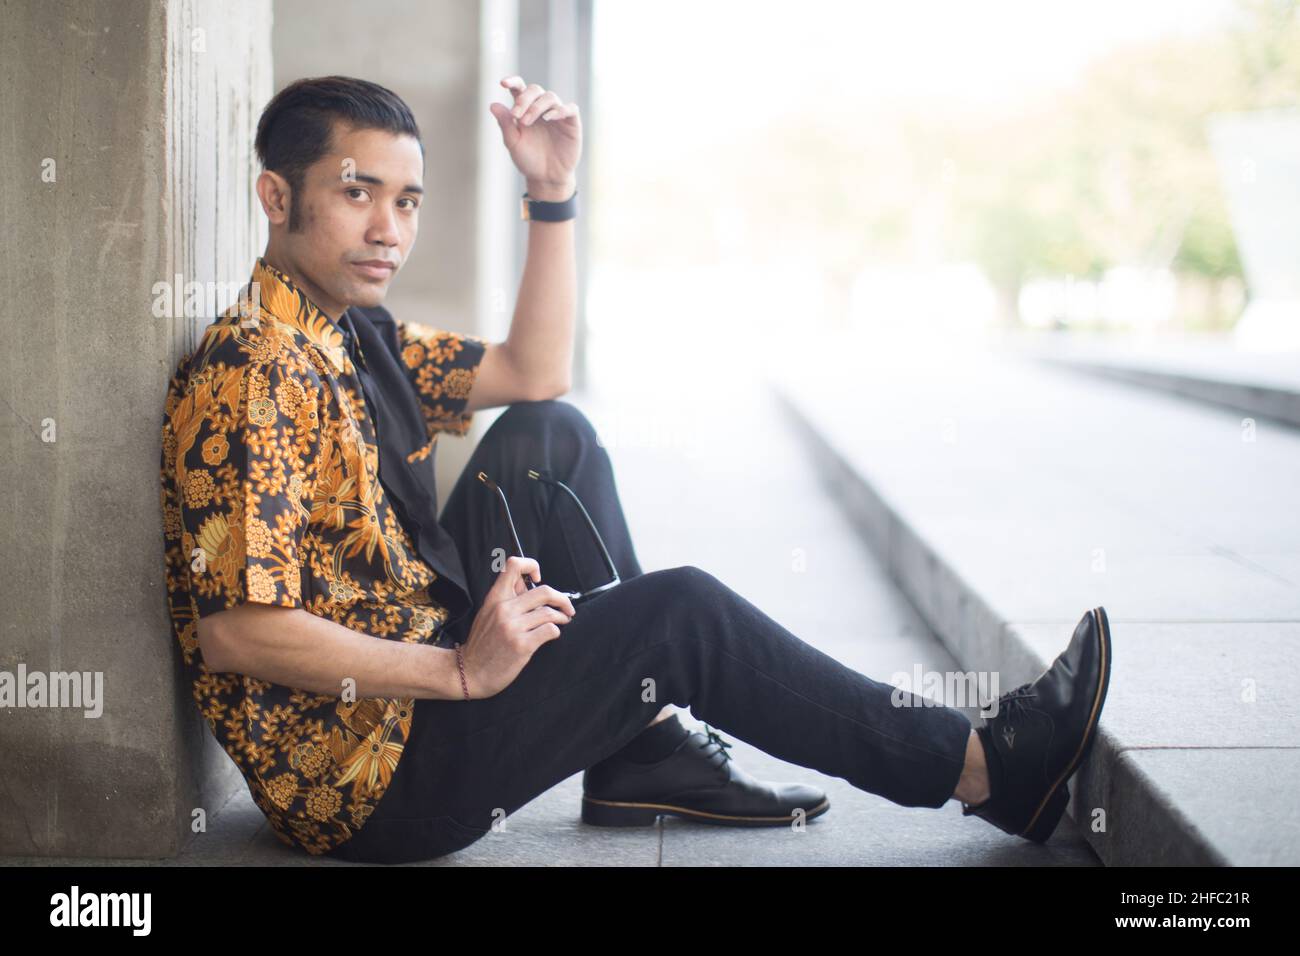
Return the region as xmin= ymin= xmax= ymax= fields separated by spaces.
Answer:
xmin=488 ymin=77 xmax=582 ymax=202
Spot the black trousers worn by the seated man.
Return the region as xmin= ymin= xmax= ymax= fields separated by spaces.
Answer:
xmin=330 ymin=401 xmax=971 ymax=862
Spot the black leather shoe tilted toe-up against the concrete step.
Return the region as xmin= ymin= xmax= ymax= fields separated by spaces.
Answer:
xmin=962 ymin=607 xmax=1110 ymax=843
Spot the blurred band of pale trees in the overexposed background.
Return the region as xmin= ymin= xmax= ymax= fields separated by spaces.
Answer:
xmin=597 ymin=0 xmax=1300 ymax=332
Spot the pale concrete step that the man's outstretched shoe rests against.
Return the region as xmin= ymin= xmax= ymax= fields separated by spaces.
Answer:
xmin=772 ymin=338 xmax=1300 ymax=865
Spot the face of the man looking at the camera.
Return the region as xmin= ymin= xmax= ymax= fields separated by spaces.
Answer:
xmin=268 ymin=124 xmax=424 ymax=317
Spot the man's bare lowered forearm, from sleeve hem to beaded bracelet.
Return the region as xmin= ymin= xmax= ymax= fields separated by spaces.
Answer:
xmin=199 ymin=604 xmax=463 ymax=700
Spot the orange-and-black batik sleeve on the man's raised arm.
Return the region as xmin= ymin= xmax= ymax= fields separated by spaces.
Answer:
xmin=397 ymin=321 xmax=488 ymax=438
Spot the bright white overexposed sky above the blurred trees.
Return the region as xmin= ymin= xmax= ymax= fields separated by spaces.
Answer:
xmin=594 ymin=0 xmax=1232 ymax=137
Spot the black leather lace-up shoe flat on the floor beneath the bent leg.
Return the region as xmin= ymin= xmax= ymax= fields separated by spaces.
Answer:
xmin=582 ymin=723 xmax=831 ymax=826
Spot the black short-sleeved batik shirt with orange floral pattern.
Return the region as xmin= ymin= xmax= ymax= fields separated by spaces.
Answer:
xmin=161 ymin=258 xmax=486 ymax=855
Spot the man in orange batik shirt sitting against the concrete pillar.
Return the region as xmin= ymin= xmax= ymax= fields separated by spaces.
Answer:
xmin=163 ymin=77 xmax=1110 ymax=862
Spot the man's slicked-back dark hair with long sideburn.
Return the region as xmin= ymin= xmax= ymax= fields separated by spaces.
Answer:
xmin=254 ymin=77 xmax=424 ymax=233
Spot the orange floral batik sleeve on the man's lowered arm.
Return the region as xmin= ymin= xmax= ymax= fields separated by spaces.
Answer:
xmin=169 ymin=362 xmax=324 ymax=617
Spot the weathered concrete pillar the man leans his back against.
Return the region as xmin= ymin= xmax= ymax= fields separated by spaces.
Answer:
xmin=0 ymin=0 xmax=270 ymax=857
